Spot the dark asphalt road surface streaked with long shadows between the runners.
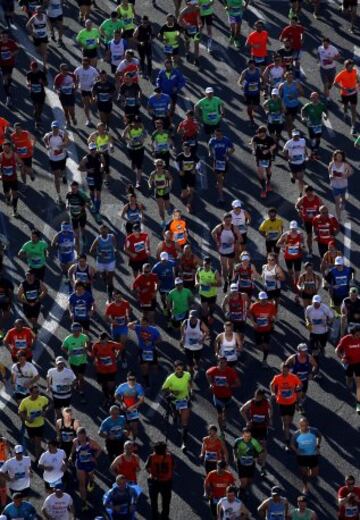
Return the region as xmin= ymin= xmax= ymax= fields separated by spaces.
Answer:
xmin=0 ymin=0 xmax=360 ymax=520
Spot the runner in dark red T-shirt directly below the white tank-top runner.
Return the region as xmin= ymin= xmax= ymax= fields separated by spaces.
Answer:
xmin=206 ymin=353 xmax=240 ymax=432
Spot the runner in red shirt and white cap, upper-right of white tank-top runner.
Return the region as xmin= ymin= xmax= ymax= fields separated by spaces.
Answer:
xmin=249 ymin=291 xmax=277 ymax=368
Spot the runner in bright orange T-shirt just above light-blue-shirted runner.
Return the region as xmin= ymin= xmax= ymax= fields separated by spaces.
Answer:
xmin=270 ymin=363 xmax=302 ymax=451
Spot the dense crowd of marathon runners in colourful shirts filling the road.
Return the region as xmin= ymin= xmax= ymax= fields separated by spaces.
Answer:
xmin=0 ymin=0 xmax=360 ymax=520
